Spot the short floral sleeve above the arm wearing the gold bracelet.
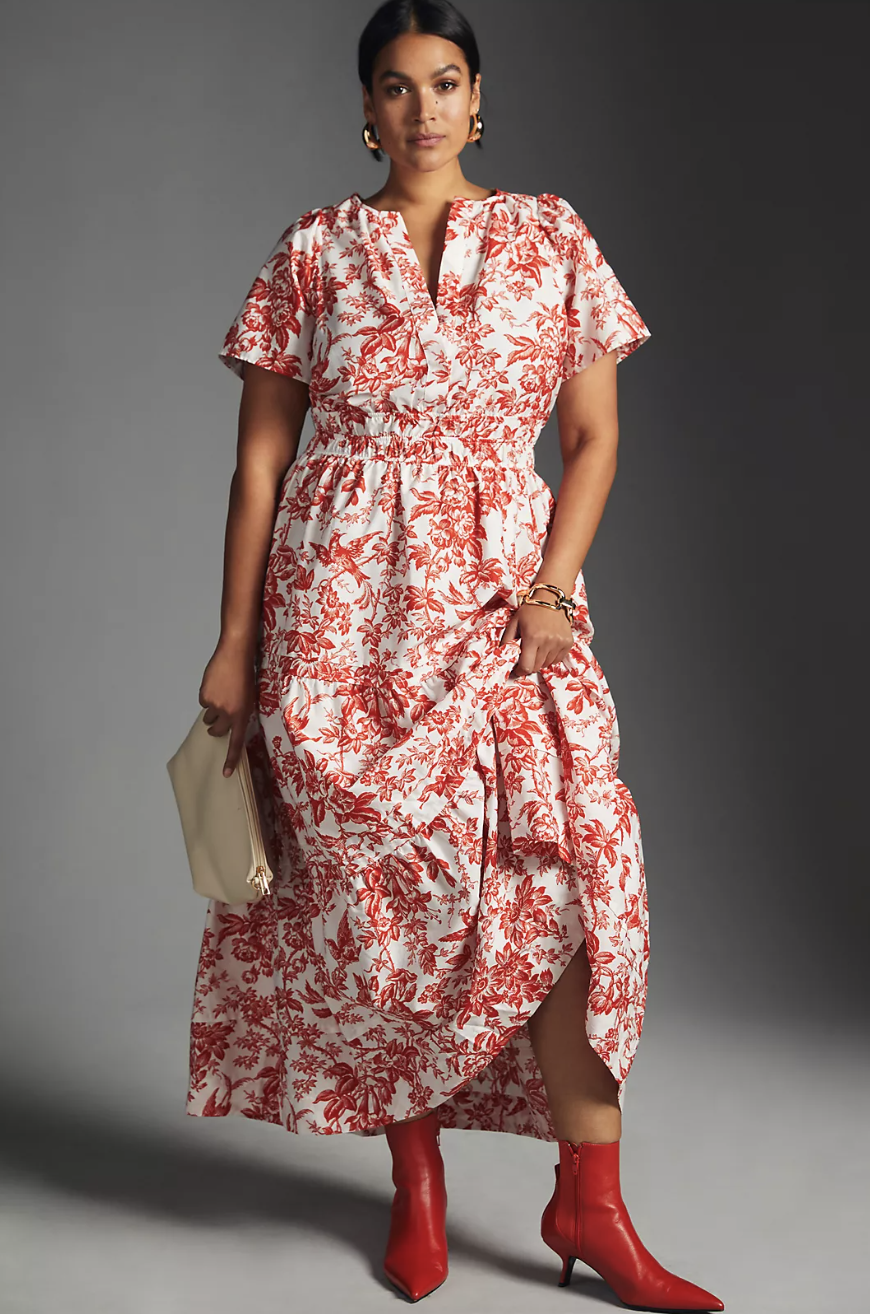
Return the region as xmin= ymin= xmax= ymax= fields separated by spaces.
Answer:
xmin=539 ymin=193 xmax=651 ymax=380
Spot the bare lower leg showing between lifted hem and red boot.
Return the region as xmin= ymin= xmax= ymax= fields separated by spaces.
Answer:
xmin=527 ymin=943 xmax=622 ymax=1143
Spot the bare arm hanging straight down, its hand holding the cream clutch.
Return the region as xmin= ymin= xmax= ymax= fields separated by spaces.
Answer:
xmin=200 ymin=363 xmax=309 ymax=775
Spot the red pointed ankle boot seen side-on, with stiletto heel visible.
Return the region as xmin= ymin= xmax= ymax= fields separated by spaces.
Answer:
xmin=540 ymin=1141 xmax=725 ymax=1311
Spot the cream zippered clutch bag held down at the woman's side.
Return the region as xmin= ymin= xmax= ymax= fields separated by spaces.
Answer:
xmin=166 ymin=707 xmax=273 ymax=903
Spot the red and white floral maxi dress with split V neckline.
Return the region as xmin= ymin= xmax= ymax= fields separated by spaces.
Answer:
xmin=187 ymin=189 xmax=649 ymax=1141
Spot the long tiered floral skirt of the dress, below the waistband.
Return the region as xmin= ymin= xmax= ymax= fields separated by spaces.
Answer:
xmin=187 ymin=432 xmax=649 ymax=1141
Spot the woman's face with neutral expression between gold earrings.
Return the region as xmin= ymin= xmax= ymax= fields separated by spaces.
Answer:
xmin=363 ymin=33 xmax=480 ymax=172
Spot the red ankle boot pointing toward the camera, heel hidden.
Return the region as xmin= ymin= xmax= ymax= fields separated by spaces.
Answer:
xmin=384 ymin=1113 xmax=447 ymax=1301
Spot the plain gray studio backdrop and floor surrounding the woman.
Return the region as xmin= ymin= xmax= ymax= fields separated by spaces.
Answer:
xmin=0 ymin=0 xmax=867 ymax=1314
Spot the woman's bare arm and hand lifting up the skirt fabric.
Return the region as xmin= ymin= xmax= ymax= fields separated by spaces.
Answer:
xmin=502 ymin=351 xmax=619 ymax=675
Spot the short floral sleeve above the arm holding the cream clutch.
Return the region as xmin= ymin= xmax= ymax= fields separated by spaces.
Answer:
xmin=219 ymin=213 xmax=317 ymax=384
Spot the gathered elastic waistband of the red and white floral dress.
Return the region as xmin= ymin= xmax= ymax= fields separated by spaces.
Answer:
xmin=302 ymin=410 xmax=539 ymax=469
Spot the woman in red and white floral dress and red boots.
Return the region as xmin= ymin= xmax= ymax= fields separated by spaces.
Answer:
xmin=188 ymin=0 xmax=724 ymax=1310
